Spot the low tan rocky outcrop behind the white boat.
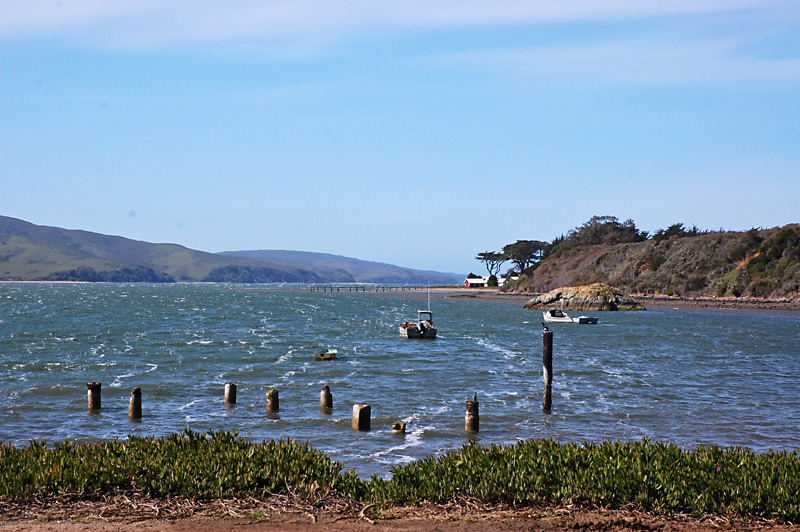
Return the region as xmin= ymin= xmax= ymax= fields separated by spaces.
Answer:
xmin=524 ymin=283 xmax=645 ymax=310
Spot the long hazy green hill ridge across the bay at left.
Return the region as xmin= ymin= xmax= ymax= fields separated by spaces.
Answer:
xmin=0 ymin=216 xmax=461 ymax=284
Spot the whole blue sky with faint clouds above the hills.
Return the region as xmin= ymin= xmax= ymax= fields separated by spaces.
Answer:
xmin=0 ymin=0 xmax=800 ymax=273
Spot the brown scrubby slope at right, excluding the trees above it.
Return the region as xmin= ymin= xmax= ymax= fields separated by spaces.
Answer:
xmin=508 ymin=224 xmax=800 ymax=298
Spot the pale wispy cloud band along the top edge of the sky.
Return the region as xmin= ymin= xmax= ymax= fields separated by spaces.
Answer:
xmin=0 ymin=0 xmax=793 ymax=48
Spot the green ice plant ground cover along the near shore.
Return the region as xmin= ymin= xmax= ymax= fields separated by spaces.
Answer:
xmin=0 ymin=430 xmax=800 ymax=522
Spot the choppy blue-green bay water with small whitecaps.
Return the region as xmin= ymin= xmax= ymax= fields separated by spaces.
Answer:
xmin=0 ymin=283 xmax=800 ymax=477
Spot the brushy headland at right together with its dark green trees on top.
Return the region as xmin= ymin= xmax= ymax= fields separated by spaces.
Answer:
xmin=476 ymin=216 xmax=800 ymax=298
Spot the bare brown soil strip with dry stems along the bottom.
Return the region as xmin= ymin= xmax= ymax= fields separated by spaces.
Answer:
xmin=0 ymin=493 xmax=800 ymax=532
